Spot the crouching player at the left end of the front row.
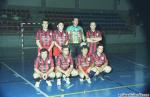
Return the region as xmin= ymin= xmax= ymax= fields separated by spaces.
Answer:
xmin=33 ymin=48 xmax=55 ymax=87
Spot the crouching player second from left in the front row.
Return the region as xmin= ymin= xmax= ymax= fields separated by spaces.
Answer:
xmin=56 ymin=45 xmax=78 ymax=85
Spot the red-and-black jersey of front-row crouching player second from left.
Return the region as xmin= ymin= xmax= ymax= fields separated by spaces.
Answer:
xmin=57 ymin=54 xmax=73 ymax=70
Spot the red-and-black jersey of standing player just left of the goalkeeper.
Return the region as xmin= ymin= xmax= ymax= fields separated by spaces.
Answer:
xmin=54 ymin=30 xmax=69 ymax=46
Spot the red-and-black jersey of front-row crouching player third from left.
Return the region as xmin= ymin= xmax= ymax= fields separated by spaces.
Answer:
xmin=77 ymin=55 xmax=93 ymax=68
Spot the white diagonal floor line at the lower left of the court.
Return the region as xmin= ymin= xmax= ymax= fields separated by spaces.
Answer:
xmin=1 ymin=62 xmax=49 ymax=97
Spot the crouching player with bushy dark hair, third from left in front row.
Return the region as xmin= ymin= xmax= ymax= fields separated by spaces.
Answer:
xmin=77 ymin=45 xmax=93 ymax=83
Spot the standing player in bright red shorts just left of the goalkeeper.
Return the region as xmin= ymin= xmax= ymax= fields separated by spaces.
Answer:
xmin=53 ymin=22 xmax=69 ymax=60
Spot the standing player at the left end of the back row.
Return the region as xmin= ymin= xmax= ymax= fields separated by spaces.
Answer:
xmin=36 ymin=20 xmax=54 ymax=57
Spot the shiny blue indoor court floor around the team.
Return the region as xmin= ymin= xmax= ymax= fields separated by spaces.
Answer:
xmin=0 ymin=44 xmax=150 ymax=97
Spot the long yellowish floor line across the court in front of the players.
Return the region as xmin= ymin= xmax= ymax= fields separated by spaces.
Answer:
xmin=49 ymin=84 xmax=145 ymax=97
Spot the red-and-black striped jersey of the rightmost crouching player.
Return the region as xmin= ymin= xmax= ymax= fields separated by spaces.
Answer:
xmin=93 ymin=53 xmax=108 ymax=67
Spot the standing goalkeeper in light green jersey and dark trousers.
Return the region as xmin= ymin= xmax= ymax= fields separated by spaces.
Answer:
xmin=67 ymin=18 xmax=85 ymax=58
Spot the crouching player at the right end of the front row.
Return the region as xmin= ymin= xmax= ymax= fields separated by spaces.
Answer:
xmin=91 ymin=44 xmax=112 ymax=79
